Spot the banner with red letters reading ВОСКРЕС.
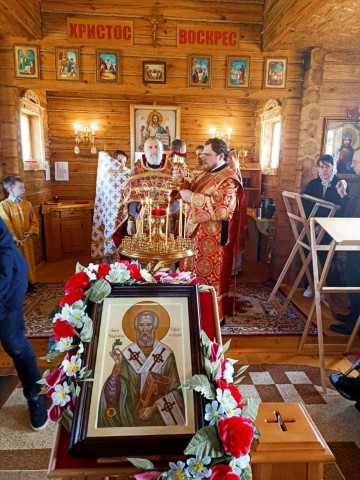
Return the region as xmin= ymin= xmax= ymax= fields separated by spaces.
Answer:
xmin=177 ymin=25 xmax=239 ymax=50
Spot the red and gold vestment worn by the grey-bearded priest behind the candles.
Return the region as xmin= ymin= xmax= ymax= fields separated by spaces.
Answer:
xmin=113 ymin=155 xmax=173 ymax=247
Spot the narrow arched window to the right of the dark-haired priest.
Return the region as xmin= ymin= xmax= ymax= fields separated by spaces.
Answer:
xmin=260 ymin=100 xmax=281 ymax=173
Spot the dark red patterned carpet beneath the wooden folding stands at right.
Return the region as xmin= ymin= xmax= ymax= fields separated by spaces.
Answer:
xmin=221 ymin=281 xmax=316 ymax=335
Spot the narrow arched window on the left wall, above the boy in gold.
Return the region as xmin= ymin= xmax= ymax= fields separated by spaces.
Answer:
xmin=20 ymin=90 xmax=45 ymax=170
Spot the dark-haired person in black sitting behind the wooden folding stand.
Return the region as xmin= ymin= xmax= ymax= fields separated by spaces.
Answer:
xmin=303 ymin=155 xmax=341 ymax=298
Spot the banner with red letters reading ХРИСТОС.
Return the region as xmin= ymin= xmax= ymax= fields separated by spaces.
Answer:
xmin=67 ymin=18 xmax=134 ymax=47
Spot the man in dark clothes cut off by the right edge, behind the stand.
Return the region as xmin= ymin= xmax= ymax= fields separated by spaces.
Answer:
xmin=330 ymin=148 xmax=360 ymax=335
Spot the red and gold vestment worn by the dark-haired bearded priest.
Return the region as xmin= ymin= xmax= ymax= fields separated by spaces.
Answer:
xmin=186 ymin=167 xmax=244 ymax=319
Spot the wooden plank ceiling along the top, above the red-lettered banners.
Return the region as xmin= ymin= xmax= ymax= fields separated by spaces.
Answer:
xmin=0 ymin=0 xmax=360 ymax=52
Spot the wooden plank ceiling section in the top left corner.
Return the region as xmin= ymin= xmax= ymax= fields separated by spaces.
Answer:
xmin=0 ymin=0 xmax=42 ymax=40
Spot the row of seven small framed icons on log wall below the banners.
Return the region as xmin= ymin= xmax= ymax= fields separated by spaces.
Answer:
xmin=14 ymin=45 xmax=287 ymax=89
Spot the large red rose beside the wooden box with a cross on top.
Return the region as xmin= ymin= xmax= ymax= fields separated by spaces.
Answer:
xmin=218 ymin=415 xmax=254 ymax=458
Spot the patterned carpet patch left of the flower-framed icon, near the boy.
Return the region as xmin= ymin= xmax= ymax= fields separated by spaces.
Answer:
xmin=24 ymin=283 xmax=64 ymax=338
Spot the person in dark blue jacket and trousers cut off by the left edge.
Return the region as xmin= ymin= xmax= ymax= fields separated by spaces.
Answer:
xmin=0 ymin=218 xmax=48 ymax=431
